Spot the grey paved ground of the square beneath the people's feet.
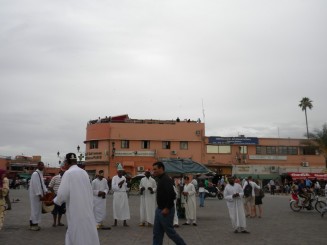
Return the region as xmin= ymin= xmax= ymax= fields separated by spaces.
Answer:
xmin=0 ymin=189 xmax=327 ymax=245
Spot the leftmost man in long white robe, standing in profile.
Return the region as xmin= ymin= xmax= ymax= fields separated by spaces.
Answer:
xmin=29 ymin=162 xmax=48 ymax=231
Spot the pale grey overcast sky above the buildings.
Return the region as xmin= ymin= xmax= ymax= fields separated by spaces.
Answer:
xmin=0 ymin=0 xmax=327 ymax=165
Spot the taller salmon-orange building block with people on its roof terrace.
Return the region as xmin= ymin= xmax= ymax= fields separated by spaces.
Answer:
xmin=85 ymin=115 xmax=205 ymax=177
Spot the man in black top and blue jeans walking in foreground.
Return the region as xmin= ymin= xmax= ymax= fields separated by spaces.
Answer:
xmin=152 ymin=162 xmax=186 ymax=245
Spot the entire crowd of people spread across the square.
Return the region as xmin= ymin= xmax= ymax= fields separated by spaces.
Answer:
xmin=0 ymin=158 xmax=327 ymax=245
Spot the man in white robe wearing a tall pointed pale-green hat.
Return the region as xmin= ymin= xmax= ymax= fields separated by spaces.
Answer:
xmin=111 ymin=163 xmax=130 ymax=226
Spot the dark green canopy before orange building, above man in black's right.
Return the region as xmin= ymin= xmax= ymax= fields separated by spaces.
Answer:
xmin=162 ymin=159 xmax=211 ymax=174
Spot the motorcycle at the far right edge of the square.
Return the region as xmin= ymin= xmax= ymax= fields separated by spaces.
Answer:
xmin=290 ymin=191 xmax=327 ymax=214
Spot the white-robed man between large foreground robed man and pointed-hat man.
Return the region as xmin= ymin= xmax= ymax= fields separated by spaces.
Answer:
xmin=92 ymin=170 xmax=110 ymax=229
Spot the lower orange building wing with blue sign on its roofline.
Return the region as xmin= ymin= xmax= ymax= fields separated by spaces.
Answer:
xmin=204 ymin=136 xmax=327 ymax=180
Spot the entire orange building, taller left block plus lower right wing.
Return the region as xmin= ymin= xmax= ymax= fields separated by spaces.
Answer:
xmin=85 ymin=115 xmax=326 ymax=179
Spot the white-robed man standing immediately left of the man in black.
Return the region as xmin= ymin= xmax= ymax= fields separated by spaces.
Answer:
xmin=140 ymin=170 xmax=157 ymax=226
